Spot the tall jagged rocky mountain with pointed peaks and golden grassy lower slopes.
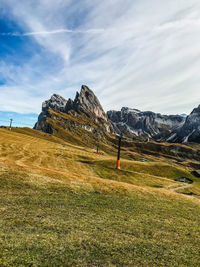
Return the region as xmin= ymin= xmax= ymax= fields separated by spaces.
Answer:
xmin=34 ymin=85 xmax=114 ymax=146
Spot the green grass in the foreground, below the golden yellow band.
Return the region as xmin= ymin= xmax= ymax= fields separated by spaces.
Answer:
xmin=0 ymin=172 xmax=200 ymax=267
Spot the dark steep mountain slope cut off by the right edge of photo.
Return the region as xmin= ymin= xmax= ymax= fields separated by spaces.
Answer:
xmin=167 ymin=105 xmax=200 ymax=143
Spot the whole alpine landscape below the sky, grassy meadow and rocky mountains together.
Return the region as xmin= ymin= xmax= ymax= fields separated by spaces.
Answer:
xmin=0 ymin=86 xmax=200 ymax=267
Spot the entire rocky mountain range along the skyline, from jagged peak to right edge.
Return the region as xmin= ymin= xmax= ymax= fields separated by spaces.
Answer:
xmin=34 ymin=85 xmax=200 ymax=143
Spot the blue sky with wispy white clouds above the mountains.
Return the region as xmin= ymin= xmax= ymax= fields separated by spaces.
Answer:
xmin=0 ymin=0 xmax=200 ymax=126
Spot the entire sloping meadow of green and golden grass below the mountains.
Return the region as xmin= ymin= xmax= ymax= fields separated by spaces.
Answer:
xmin=0 ymin=128 xmax=200 ymax=267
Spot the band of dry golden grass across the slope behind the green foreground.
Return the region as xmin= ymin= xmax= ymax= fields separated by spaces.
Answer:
xmin=0 ymin=129 xmax=198 ymax=203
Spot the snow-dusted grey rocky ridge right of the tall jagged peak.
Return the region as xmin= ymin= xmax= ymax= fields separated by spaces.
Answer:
xmin=107 ymin=107 xmax=185 ymax=141
